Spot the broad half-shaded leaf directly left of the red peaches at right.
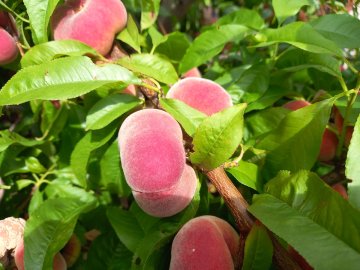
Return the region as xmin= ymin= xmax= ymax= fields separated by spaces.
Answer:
xmin=256 ymin=99 xmax=334 ymax=176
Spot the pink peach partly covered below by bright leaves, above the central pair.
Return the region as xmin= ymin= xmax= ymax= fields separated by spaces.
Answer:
xmin=166 ymin=77 xmax=233 ymax=115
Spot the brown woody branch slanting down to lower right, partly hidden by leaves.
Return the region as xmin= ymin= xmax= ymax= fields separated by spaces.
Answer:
xmin=206 ymin=167 xmax=301 ymax=270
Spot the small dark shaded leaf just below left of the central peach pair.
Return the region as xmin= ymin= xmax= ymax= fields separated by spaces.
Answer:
xmin=106 ymin=207 xmax=145 ymax=252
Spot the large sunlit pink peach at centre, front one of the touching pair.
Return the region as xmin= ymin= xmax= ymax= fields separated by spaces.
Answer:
xmin=118 ymin=109 xmax=185 ymax=193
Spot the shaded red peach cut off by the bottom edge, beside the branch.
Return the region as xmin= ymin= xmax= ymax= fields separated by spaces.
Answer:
xmin=170 ymin=216 xmax=239 ymax=270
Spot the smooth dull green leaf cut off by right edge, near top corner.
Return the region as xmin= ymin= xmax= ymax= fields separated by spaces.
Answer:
xmin=311 ymin=14 xmax=360 ymax=49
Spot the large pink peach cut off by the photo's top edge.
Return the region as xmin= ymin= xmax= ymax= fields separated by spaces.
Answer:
xmin=51 ymin=0 xmax=127 ymax=55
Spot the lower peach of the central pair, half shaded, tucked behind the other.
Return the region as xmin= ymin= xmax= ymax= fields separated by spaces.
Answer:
xmin=133 ymin=165 xmax=197 ymax=217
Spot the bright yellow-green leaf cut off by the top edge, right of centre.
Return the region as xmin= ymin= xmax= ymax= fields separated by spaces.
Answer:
xmin=272 ymin=0 xmax=312 ymax=24
